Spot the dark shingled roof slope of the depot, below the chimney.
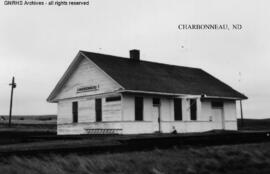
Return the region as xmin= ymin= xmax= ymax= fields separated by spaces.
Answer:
xmin=80 ymin=51 xmax=247 ymax=99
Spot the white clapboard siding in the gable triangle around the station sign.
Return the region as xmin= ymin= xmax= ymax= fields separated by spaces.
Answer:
xmin=56 ymin=58 xmax=120 ymax=100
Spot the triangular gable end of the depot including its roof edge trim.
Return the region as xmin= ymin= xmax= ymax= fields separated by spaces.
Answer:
xmin=47 ymin=52 xmax=123 ymax=102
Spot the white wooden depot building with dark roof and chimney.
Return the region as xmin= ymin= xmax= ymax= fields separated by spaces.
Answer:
xmin=47 ymin=50 xmax=247 ymax=134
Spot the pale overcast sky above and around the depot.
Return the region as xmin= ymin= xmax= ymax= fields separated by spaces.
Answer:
xmin=0 ymin=0 xmax=270 ymax=118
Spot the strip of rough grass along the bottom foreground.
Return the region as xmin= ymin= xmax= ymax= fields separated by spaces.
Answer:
xmin=0 ymin=143 xmax=270 ymax=174
